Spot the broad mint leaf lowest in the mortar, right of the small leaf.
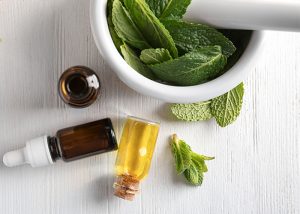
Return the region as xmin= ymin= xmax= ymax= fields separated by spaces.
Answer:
xmin=149 ymin=46 xmax=227 ymax=86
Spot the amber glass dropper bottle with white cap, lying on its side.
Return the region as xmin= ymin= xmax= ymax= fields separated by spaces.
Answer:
xmin=3 ymin=118 xmax=118 ymax=167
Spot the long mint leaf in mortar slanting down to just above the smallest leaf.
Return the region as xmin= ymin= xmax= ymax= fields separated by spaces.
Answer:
xmin=124 ymin=0 xmax=178 ymax=57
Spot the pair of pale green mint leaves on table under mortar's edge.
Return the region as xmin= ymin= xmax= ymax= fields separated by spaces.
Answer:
xmin=171 ymin=83 xmax=244 ymax=127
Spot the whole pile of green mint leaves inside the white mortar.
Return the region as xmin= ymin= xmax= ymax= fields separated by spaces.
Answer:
xmin=107 ymin=0 xmax=235 ymax=86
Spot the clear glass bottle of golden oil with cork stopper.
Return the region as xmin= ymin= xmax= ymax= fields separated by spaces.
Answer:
xmin=114 ymin=116 xmax=159 ymax=200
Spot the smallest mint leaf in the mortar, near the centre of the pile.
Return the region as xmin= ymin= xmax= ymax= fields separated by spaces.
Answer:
xmin=140 ymin=48 xmax=172 ymax=65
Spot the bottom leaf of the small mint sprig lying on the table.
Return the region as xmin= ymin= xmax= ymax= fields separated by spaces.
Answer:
xmin=184 ymin=161 xmax=203 ymax=186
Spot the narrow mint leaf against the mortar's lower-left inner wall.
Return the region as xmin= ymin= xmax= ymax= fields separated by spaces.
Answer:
xmin=121 ymin=44 xmax=155 ymax=79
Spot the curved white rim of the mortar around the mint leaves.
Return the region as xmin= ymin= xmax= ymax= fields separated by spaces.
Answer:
xmin=90 ymin=0 xmax=263 ymax=103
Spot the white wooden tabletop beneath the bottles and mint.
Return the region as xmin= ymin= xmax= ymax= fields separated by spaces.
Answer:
xmin=0 ymin=0 xmax=300 ymax=214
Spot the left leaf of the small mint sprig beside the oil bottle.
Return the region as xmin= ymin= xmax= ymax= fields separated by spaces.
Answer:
xmin=171 ymin=134 xmax=191 ymax=174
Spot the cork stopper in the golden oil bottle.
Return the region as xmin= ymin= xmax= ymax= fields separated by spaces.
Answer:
xmin=113 ymin=175 xmax=140 ymax=201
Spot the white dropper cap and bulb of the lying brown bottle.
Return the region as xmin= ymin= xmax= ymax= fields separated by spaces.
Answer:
xmin=3 ymin=135 xmax=53 ymax=167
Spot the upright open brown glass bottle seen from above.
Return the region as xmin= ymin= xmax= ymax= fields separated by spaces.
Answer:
xmin=58 ymin=66 xmax=100 ymax=108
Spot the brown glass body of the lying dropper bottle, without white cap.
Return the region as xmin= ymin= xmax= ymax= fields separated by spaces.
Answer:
xmin=49 ymin=119 xmax=117 ymax=161
